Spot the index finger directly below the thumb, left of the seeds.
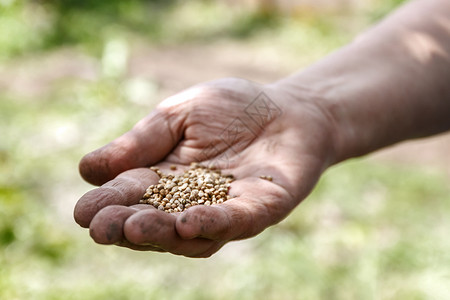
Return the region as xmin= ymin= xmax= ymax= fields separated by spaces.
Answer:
xmin=74 ymin=168 xmax=159 ymax=228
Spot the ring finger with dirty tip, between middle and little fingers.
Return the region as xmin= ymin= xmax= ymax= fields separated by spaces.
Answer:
xmin=123 ymin=209 xmax=216 ymax=256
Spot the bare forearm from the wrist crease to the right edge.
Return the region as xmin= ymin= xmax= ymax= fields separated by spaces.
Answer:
xmin=274 ymin=0 xmax=450 ymax=162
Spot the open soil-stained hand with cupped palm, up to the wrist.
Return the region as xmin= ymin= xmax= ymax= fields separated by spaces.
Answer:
xmin=74 ymin=79 xmax=333 ymax=257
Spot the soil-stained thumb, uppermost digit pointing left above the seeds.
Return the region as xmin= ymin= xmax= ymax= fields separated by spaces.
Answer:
xmin=79 ymin=109 xmax=182 ymax=185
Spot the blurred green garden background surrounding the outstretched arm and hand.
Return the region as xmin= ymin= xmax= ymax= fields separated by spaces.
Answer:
xmin=0 ymin=0 xmax=450 ymax=300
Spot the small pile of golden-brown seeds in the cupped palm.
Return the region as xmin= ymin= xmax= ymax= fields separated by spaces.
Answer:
xmin=140 ymin=163 xmax=234 ymax=213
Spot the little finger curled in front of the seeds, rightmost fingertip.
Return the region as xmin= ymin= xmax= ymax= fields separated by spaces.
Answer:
xmin=175 ymin=178 xmax=294 ymax=241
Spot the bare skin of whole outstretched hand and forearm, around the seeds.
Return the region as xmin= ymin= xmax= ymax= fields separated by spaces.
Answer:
xmin=74 ymin=0 xmax=450 ymax=257
